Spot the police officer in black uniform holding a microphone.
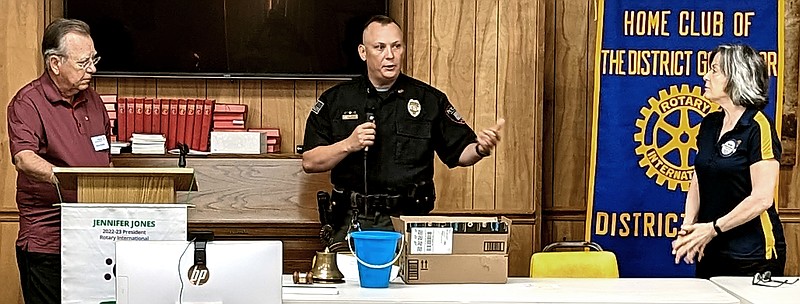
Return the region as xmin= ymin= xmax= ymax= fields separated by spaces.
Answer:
xmin=303 ymin=16 xmax=504 ymax=242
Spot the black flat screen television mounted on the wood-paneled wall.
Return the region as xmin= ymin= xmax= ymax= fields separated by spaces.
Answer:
xmin=64 ymin=0 xmax=387 ymax=78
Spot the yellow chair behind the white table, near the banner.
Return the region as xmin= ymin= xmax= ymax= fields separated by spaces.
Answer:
xmin=530 ymin=241 xmax=619 ymax=278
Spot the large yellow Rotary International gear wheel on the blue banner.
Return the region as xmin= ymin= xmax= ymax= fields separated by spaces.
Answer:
xmin=633 ymin=84 xmax=719 ymax=192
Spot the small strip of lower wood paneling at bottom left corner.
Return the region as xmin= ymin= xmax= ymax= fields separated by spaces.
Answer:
xmin=0 ymin=220 xmax=23 ymax=304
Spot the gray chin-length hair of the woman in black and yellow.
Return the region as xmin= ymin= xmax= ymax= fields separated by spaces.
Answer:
xmin=708 ymin=44 xmax=769 ymax=109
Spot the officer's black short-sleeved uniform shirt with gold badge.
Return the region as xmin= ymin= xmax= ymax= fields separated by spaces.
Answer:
xmin=303 ymin=74 xmax=476 ymax=193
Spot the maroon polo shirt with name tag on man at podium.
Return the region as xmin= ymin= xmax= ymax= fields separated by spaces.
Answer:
xmin=8 ymin=72 xmax=111 ymax=253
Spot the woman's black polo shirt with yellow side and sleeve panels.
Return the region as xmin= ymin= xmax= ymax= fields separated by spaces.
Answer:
xmin=694 ymin=108 xmax=786 ymax=259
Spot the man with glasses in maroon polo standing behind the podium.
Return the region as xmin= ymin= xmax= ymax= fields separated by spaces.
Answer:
xmin=8 ymin=19 xmax=111 ymax=303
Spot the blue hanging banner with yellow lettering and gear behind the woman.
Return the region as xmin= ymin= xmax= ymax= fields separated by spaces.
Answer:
xmin=586 ymin=0 xmax=784 ymax=277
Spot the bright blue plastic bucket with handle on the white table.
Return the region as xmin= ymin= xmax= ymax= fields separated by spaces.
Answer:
xmin=350 ymin=230 xmax=403 ymax=288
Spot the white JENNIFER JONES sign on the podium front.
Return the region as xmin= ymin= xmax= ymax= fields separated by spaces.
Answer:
xmin=61 ymin=204 xmax=187 ymax=304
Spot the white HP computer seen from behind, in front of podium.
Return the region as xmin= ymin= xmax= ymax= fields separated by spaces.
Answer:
xmin=116 ymin=241 xmax=283 ymax=304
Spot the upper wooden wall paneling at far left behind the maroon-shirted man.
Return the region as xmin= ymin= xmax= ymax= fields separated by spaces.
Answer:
xmin=0 ymin=0 xmax=46 ymax=213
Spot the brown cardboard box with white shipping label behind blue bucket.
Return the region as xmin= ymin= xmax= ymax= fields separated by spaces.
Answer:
xmin=392 ymin=216 xmax=511 ymax=284
